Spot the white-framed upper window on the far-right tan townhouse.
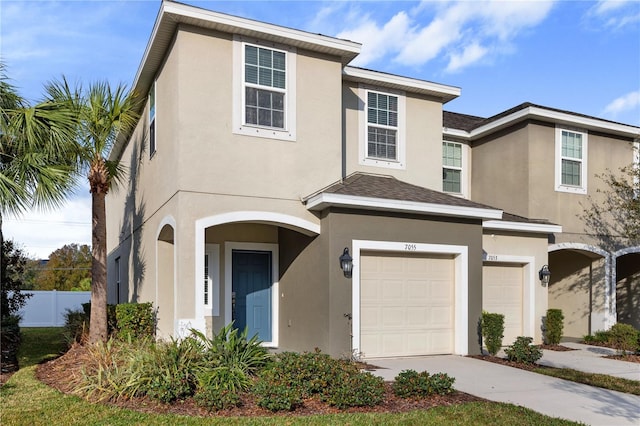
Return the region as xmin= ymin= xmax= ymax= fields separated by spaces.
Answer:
xmin=555 ymin=127 xmax=588 ymax=194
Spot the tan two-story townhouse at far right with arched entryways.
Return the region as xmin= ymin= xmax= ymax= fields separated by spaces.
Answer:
xmin=443 ymin=103 xmax=640 ymax=338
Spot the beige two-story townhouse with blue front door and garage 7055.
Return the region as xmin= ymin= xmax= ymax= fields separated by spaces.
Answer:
xmin=107 ymin=0 xmax=637 ymax=358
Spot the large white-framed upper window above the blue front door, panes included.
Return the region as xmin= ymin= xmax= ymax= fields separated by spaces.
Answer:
xmin=233 ymin=36 xmax=296 ymax=141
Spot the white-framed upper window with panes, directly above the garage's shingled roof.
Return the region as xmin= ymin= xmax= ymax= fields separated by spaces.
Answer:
xmin=360 ymin=87 xmax=406 ymax=169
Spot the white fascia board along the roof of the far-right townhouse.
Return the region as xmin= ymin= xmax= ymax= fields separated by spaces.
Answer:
xmin=469 ymin=106 xmax=640 ymax=138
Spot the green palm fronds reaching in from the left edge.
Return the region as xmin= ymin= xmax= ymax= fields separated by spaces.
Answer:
xmin=0 ymin=63 xmax=77 ymax=290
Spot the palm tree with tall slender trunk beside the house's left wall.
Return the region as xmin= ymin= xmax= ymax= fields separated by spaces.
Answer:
xmin=48 ymin=78 xmax=138 ymax=343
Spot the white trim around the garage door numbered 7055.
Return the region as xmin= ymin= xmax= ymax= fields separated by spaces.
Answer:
xmin=351 ymin=240 xmax=469 ymax=355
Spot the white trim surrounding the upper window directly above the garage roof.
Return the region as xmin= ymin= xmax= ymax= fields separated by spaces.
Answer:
xmin=358 ymin=84 xmax=407 ymax=170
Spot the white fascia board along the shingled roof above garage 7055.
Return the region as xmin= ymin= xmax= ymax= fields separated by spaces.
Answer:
xmin=307 ymin=193 xmax=502 ymax=219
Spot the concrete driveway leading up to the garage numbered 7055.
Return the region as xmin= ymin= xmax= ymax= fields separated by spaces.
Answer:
xmin=370 ymin=351 xmax=640 ymax=426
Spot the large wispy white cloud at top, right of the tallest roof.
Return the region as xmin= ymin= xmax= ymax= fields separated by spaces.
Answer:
xmin=338 ymin=0 xmax=554 ymax=71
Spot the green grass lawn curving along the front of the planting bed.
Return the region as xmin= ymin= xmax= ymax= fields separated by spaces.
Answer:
xmin=0 ymin=328 xmax=577 ymax=426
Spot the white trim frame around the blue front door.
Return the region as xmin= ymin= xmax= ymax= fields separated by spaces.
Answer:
xmin=224 ymin=242 xmax=280 ymax=348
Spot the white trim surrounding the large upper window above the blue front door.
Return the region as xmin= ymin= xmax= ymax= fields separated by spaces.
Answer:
xmin=232 ymin=34 xmax=297 ymax=141
